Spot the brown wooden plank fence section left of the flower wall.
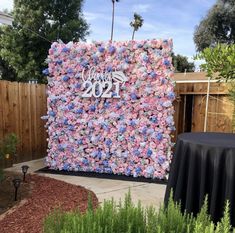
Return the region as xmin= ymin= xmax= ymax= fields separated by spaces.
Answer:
xmin=0 ymin=81 xmax=47 ymax=167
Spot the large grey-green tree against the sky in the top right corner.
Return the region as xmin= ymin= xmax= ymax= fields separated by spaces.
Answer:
xmin=194 ymin=0 xmax=235 ymax=51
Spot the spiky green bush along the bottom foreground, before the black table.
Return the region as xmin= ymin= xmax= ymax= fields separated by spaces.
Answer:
xmin=44 ymin=193 xmax=232 ymax=233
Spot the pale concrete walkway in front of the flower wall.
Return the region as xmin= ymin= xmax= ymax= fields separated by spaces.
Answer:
xmin=5 ymin=159 xmax=166 ymax=208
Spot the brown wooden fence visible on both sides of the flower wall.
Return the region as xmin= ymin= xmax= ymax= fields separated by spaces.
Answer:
xmin=0 ymin=73 xmax=233 ymax=167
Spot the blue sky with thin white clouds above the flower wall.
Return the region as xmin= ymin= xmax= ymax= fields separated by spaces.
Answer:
xmin=0 ymin=0 xmax=216 ymax=57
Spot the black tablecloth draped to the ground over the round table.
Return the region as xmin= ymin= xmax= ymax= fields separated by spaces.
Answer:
xmin=165 ymin=133 xmax=235 ymax=226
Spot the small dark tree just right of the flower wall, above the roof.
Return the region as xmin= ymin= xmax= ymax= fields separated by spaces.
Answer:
xmin=172 ymin=53 xmax=195 ymax=72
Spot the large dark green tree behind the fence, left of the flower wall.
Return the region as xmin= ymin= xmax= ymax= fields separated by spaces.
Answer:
xmin=0 ymin=0 xmax=88 ymax=82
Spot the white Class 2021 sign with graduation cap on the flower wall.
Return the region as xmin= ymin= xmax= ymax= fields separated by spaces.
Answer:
xmin=82 ymin=67 xmax=127 ymax=98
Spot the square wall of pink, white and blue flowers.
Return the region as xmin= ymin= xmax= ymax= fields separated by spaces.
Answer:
xmin=44 ymin=39 xmax=175 ymax=179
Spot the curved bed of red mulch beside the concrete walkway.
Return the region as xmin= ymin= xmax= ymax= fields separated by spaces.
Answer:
xmin=0 ymin=175 xmax=98 ymax=233
